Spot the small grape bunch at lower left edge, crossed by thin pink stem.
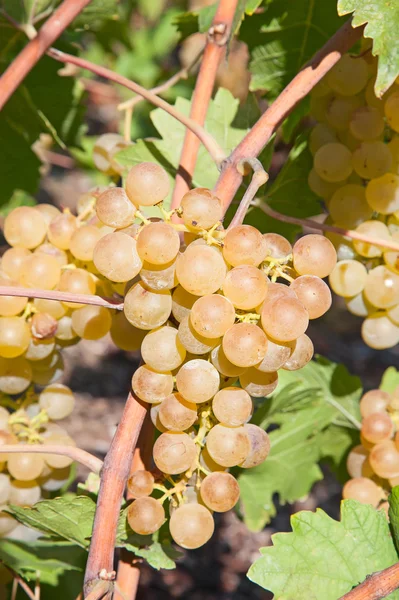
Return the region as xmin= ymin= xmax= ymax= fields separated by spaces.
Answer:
xmin=0 ymin=384 xmax=75 ymax=538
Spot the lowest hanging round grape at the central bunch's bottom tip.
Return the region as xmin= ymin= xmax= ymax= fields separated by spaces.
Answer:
xmin=169 ymin=504 xmax=215 ymax=550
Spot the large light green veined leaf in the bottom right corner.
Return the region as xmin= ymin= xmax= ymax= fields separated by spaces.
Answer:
xmin=248 ymin=500 xmax=399 ymax=600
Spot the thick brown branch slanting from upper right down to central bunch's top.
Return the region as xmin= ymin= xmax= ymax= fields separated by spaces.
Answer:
xmin=214 ymin=20 xmax=364 ymax=210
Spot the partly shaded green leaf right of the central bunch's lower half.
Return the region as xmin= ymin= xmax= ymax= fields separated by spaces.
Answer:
xmin=238 ymin=358 xmax=362 ymax=531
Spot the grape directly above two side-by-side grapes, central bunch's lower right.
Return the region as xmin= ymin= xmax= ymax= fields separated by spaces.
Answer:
xmin=212 ymin=387 xmax=253 ymax=427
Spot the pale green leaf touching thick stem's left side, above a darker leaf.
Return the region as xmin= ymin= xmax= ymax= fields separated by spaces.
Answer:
xmin=7 ymin=496 xmax=96 ymax=548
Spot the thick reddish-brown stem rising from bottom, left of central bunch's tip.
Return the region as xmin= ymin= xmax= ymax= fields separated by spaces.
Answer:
xmin=85 ymin=393 xmax=147 ymax=598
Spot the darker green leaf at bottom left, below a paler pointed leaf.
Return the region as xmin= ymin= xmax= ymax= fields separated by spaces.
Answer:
xmin=0 ymin=538 xmax=86 ymax=584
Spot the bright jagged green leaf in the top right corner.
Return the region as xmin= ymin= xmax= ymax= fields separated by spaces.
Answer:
xmin=338 ymin=0 xmax=399 ymax=97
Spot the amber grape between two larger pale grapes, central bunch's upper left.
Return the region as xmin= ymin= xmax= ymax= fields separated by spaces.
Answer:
xmin=137 ymin=221 xmax=180 ymax=265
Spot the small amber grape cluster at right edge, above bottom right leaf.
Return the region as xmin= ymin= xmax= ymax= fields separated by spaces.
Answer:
xmin=343 ymin=388 xmax=399 ymax=509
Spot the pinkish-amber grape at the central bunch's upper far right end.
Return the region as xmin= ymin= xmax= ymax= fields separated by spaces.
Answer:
xmin=293 ymin=234 xmax=337 ymax=278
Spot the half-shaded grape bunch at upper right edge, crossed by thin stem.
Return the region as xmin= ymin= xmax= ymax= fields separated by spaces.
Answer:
xmin=308 ymin=52 xmax=399 ymax=349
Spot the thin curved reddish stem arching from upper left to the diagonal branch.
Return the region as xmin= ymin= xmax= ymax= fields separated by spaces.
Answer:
xmin=47 ymin=48 xmax=226 ymax=164
